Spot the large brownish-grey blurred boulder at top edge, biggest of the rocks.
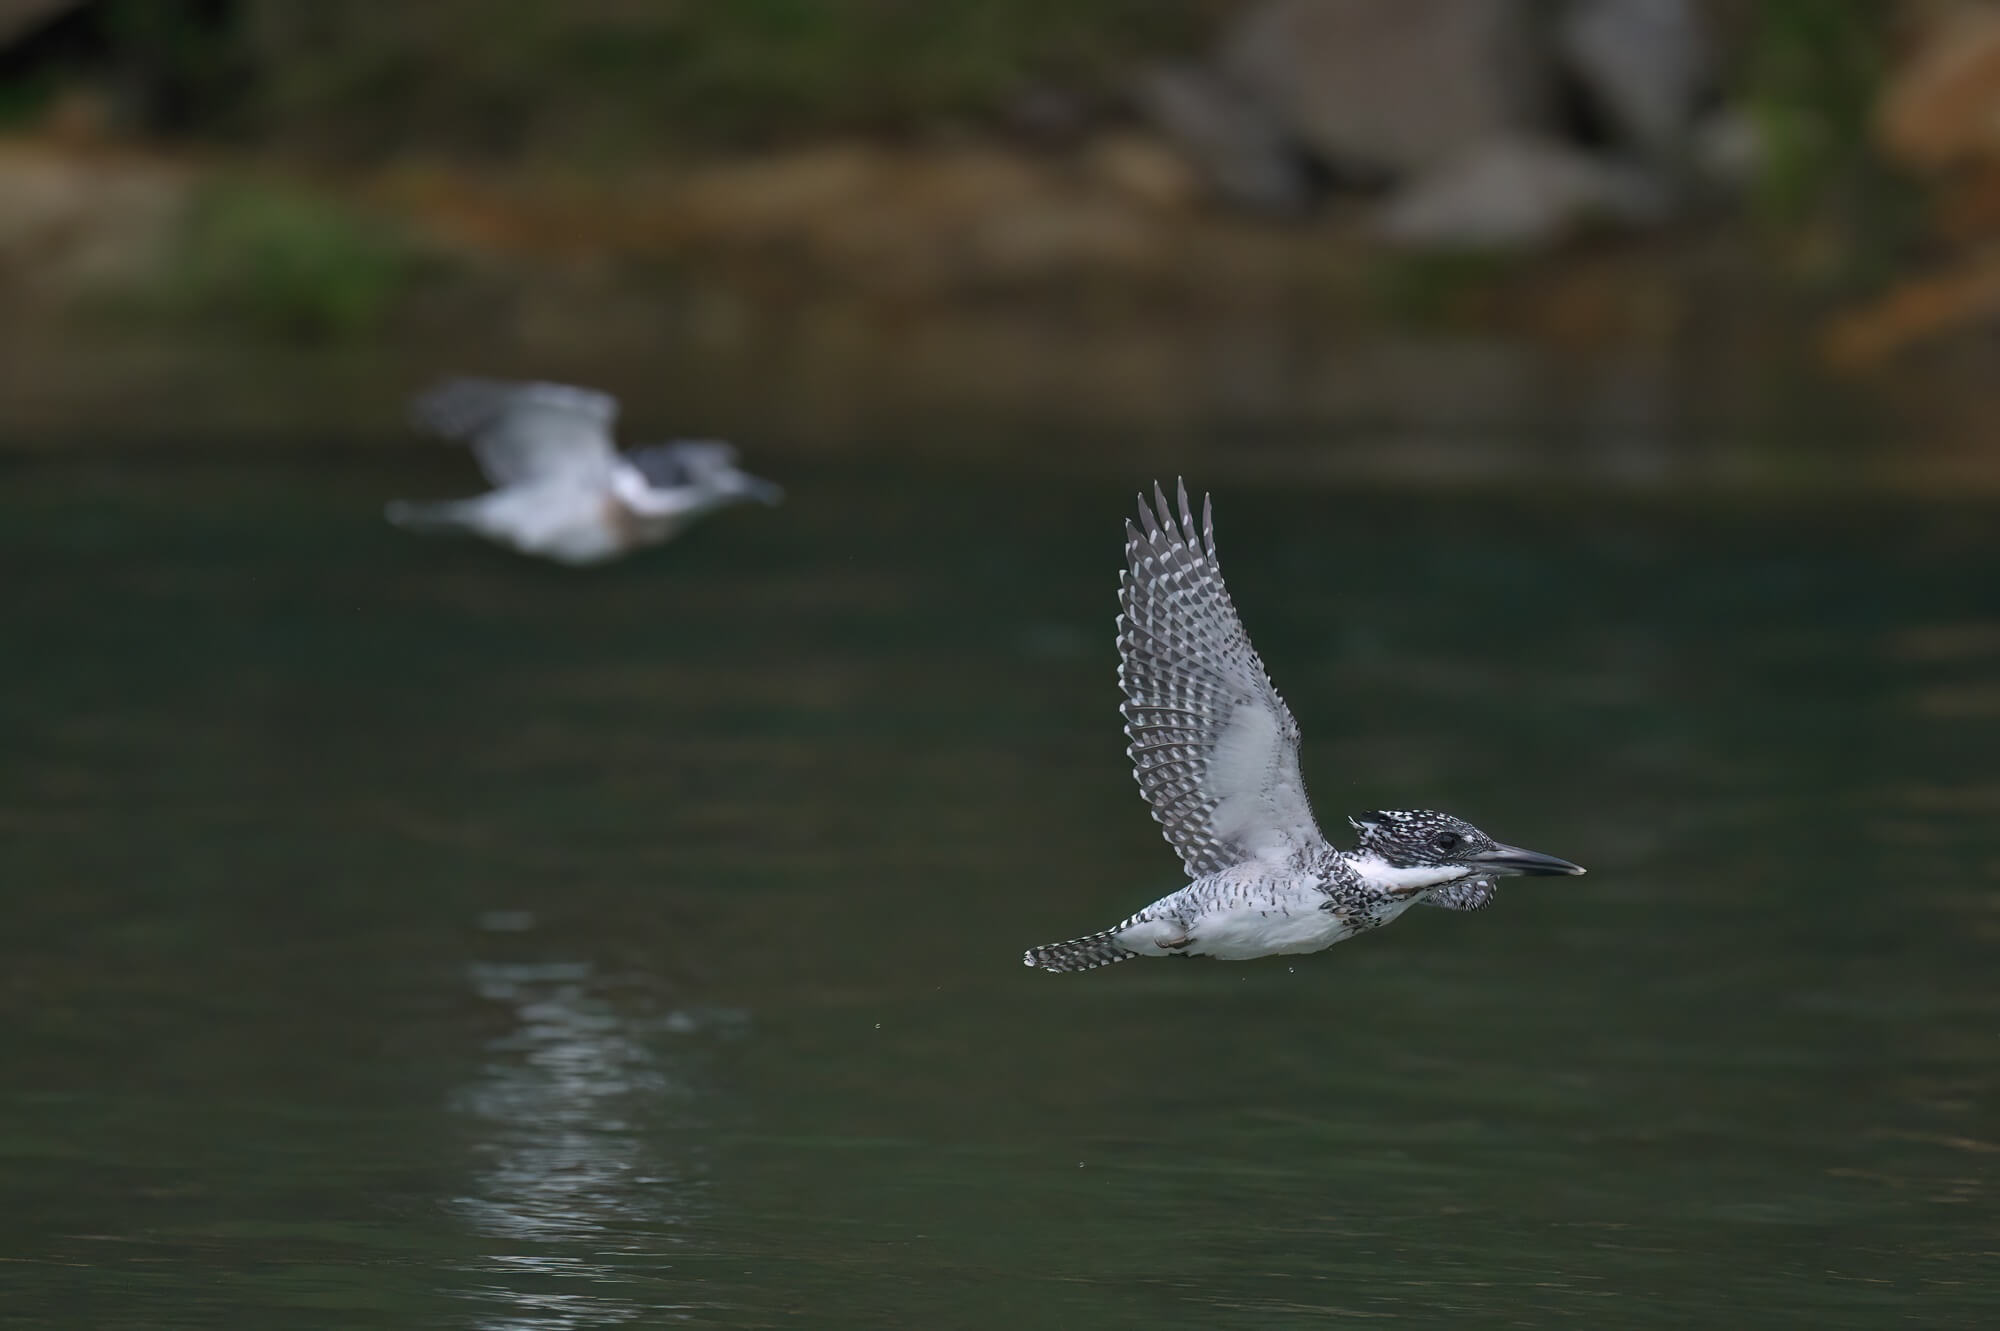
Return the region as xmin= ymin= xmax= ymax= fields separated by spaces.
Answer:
xmin=1220 ymin=0 xmax=1554 ymax=176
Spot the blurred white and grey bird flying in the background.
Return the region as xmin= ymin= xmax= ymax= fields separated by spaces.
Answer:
xmin=388 ymin=380 xmax=784 ymax=564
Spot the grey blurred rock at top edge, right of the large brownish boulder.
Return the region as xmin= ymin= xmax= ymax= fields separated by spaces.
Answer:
xmin=1558 ymin=0 xmax=1714 ymax=154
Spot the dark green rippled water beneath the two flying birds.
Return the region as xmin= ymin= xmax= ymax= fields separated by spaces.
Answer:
xmin=0 ymin=454 xmax=2000 ymax=1329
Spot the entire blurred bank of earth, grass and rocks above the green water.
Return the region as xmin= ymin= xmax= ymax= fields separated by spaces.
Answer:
xmin=11 ymin=0 xmax=2000 ymax=488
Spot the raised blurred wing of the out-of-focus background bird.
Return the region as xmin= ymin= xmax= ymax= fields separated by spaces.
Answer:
xmin=410 ymin=380 xmax=618 ymax=488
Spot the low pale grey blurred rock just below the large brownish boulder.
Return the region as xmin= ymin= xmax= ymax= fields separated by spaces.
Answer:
xmin=1376 ymin=134 xmax=1666 ymax=250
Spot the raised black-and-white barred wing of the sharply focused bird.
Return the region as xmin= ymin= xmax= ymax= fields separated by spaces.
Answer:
xmin=1118 ymin=484 xmax=1326 ymax=877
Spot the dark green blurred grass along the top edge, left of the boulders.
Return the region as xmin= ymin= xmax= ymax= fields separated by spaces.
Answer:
xmin=132 ymin=0 xmax=1232 ymax=162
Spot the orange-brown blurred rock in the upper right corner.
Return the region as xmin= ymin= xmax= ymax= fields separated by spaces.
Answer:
xmin=1876 ymin=4 xmax=2000 ymax=170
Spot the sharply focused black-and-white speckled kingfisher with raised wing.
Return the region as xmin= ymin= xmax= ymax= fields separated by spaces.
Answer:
xmin=1024 ymin=484 xmax=1584 ymax=971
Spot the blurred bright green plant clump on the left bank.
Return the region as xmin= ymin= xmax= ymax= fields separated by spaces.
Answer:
xmin=158 ymin=180 xmax=414 ymax=342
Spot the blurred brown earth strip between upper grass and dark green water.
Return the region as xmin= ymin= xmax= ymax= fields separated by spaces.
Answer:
xmin=0 ymin=132 xmax=2000 ymax=488
